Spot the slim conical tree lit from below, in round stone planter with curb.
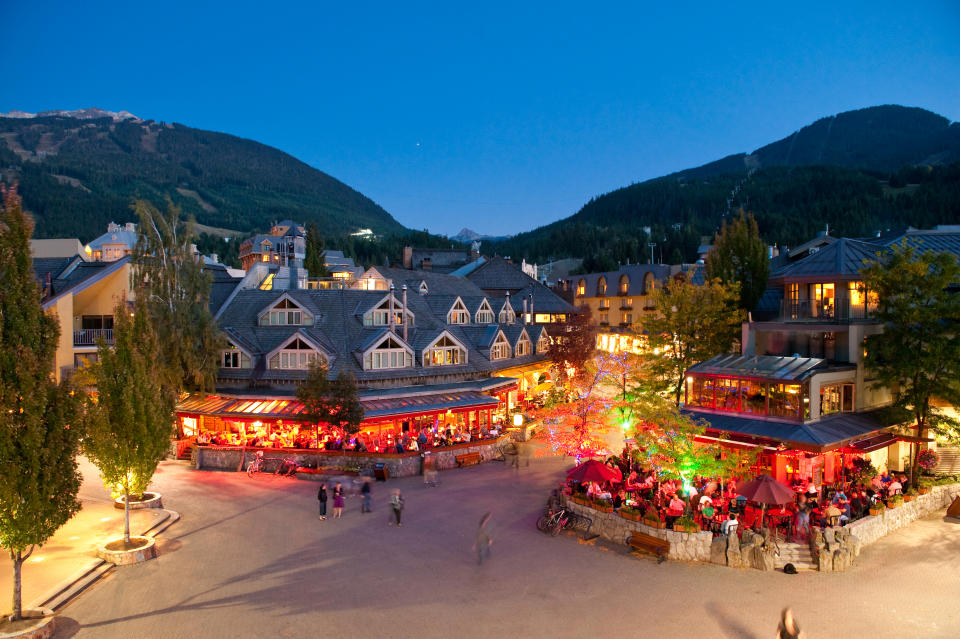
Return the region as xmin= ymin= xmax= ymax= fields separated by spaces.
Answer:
xmin=84 ymin=298 xmax=175 ymax=543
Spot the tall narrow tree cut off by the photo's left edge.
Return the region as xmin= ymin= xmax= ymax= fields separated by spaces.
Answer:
xmin=0 ymin=184 xmax=82 ymax=621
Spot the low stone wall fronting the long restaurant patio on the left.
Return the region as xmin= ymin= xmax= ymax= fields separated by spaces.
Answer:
xmin=194 ymin=435 xmax=510 ymax=477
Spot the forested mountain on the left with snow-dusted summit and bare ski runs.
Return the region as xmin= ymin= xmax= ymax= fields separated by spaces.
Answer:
xmin=0 ymin=109 xmax=406 ymax=241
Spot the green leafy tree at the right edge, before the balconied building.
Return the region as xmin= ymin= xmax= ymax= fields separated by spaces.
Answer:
xmin=861 ymin=243 xmax=960 ymax=486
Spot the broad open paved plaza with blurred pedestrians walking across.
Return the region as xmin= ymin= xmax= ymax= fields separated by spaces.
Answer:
xmin=20 ymin=459 xmax=960 ymax=639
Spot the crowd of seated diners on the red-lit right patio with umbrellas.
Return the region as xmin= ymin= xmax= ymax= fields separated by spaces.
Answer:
xmin=564 ymin=461 xmax=910 ymax=541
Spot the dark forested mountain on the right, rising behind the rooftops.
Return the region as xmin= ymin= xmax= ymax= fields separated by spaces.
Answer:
xmin=497 ymin=105 xmax=960 ymax=271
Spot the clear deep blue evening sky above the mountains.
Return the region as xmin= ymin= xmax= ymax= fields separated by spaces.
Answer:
xmin=0 ymin=0 xmax=960 ymax=234
